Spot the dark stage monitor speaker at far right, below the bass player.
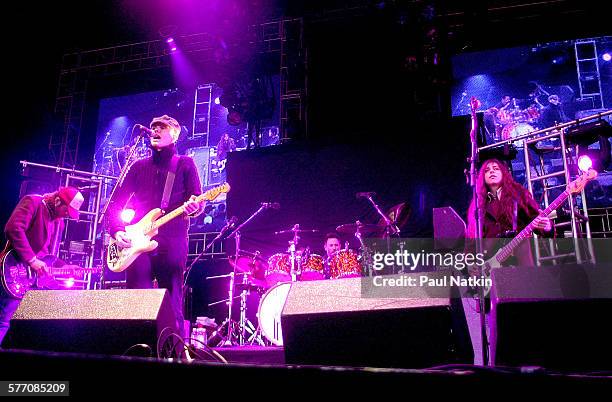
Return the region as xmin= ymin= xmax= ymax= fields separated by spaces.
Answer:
xmin=491 ymin=264 xmax=612 ymax=371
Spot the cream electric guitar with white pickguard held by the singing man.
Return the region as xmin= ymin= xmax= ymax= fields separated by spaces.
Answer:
xmin=106 ymin=183 xmax=230 ymax=272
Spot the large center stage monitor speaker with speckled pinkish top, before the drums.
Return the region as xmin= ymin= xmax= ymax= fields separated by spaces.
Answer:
xmin=281 ymin=272 xmax=473 ymax=368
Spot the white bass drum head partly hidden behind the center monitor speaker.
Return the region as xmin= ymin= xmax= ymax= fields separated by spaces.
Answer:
xmin=257 ymin=282 xmax=291 ymax=346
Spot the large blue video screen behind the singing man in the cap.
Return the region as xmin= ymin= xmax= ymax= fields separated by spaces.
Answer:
xmin=94 ymin=77 xmax=280 ymax=232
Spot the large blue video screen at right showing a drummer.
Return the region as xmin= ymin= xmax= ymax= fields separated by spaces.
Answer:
xmin=451 ymin=36 xmax=612 ymax=207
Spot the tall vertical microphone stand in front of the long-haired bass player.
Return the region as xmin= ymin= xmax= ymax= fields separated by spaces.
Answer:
xmin=468 ymin=98 xmax=489 ymax=366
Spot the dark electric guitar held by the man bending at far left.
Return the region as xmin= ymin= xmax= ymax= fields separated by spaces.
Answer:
xmin=1 ymin=249 xmax=101 ymax=299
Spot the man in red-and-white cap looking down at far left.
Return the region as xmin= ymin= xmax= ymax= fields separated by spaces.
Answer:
xmin=0 ymin=187 xmax=84 ymax=342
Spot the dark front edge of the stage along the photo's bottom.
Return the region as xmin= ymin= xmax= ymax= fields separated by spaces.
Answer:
xmin=0 ymin=351 xmax=612 ymax=399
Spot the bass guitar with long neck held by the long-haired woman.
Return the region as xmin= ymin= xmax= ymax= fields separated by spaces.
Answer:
xmin=482 ymin=169 xmax=597 ymax=294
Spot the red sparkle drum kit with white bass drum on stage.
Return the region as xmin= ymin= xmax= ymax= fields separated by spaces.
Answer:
xmin=207 ymin=224 xmax=368 ymax=346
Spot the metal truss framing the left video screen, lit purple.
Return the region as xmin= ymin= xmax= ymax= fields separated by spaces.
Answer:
xmin=49 ymin=18 xmax=306 ymax=168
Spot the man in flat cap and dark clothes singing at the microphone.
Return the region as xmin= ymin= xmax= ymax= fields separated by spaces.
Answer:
xmin=107 ymin=115 xmax=204 ymax=330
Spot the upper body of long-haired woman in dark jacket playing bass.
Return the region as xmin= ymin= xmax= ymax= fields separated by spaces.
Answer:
xmin=466 ymin=159 xmax=553 ymax=266
